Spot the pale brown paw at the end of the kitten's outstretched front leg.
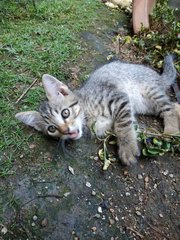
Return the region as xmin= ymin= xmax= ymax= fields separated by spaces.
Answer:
xmin=118 ymin=142 xmax=140 ymax=166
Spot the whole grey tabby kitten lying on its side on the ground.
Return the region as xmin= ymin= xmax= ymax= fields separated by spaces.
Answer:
xmin=16 ymin=55 xmax=180 ymax=165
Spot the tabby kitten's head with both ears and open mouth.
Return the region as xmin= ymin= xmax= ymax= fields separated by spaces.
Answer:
xmin=16 ymin=74 xmax=84 ymax=139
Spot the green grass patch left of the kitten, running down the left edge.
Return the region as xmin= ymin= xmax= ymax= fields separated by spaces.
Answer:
xmin=0 ymin=0 xmax=123 ymax=229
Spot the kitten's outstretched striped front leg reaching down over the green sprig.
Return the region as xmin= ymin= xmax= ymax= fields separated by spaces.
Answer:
xmin=114 ymin=97 xmax=140 ymax=165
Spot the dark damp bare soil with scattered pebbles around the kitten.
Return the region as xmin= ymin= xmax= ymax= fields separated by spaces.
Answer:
xmin=0 ymin=0 xmax=180 ymax=240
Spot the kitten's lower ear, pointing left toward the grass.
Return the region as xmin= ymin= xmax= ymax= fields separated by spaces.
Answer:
xmin=15 ymin=111 xmax=44 ymax=132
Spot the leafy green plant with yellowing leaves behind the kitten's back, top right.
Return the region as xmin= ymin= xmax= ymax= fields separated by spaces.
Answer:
xmin=115 ymin=0 xmax=180 ymax=71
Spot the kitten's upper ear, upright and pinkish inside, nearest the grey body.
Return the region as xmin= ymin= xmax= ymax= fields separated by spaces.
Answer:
xmin=42 ymin=74 xmax=71 ymax=100
